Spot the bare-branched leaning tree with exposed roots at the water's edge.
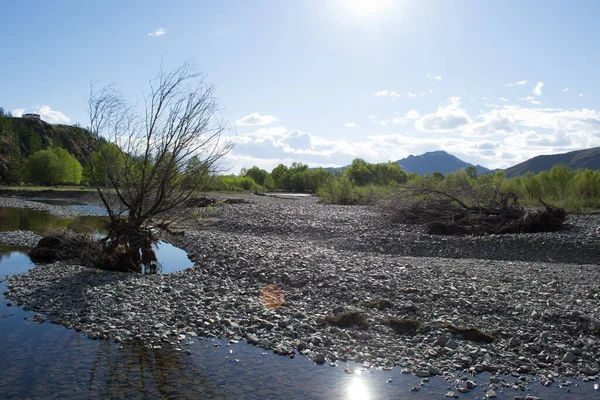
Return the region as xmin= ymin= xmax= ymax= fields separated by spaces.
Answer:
xmin=88 ymin=62 xmax=233 ymax=272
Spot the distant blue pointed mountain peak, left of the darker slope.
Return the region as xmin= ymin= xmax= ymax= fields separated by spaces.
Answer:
xmin=398 ymin=150 xmax=491 ymax=175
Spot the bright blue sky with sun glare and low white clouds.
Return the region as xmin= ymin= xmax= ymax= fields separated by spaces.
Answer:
xmin=0 ymin=0 xmax=600 ymax=173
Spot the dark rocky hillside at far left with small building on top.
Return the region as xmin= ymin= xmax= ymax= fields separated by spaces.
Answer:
xmin=0 ymin=116 xmax=97 ymax=184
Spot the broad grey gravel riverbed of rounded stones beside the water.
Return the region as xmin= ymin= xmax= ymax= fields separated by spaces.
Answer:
xmin=3 ymin=196 xmax=600 ymax=383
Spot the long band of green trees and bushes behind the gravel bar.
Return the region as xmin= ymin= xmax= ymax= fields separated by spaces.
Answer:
xmin=210 ymin=159 xmax=600 ymax=212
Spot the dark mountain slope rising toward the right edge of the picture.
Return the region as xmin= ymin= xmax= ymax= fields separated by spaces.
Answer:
xmin=505 ymin=147 xmax=600 ymax=178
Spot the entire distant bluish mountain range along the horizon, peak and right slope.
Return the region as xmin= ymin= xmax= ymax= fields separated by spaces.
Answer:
xmin=325 ymin=147 xmax=600 ymax=178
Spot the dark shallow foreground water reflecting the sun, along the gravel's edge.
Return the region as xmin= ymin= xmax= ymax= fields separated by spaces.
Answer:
xmin=0 ymin=249 xmax=600 ymax=400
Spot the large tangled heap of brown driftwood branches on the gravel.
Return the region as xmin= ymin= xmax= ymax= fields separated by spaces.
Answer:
xmin=382 ymin=188 xmax=567 ymax=235
